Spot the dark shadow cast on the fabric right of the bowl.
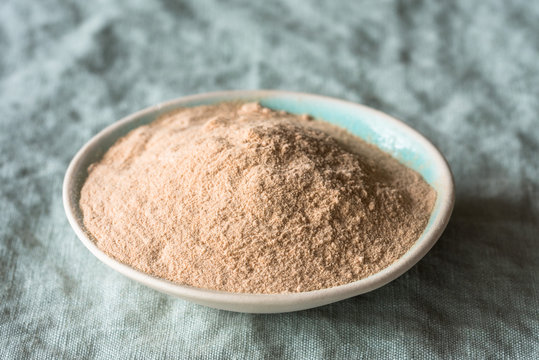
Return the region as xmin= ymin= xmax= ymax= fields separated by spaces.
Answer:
xmin=246 ymin=196 xmax=538 ymax=351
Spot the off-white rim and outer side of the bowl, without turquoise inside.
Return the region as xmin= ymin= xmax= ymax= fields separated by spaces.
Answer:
xmin=62 ymin=90 xmax=455 ymax=313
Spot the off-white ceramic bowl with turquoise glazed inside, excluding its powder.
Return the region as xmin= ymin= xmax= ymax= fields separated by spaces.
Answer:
xmin=63 ymin=90 xmax=454 ymax=313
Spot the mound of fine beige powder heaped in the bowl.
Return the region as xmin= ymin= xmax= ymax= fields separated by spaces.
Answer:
xmin=80 ymin=102 xmax=436 ymax=293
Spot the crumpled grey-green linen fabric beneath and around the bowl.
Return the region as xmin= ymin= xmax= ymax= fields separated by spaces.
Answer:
xmin=0 ymin=0 xmax=539 ymax=359
